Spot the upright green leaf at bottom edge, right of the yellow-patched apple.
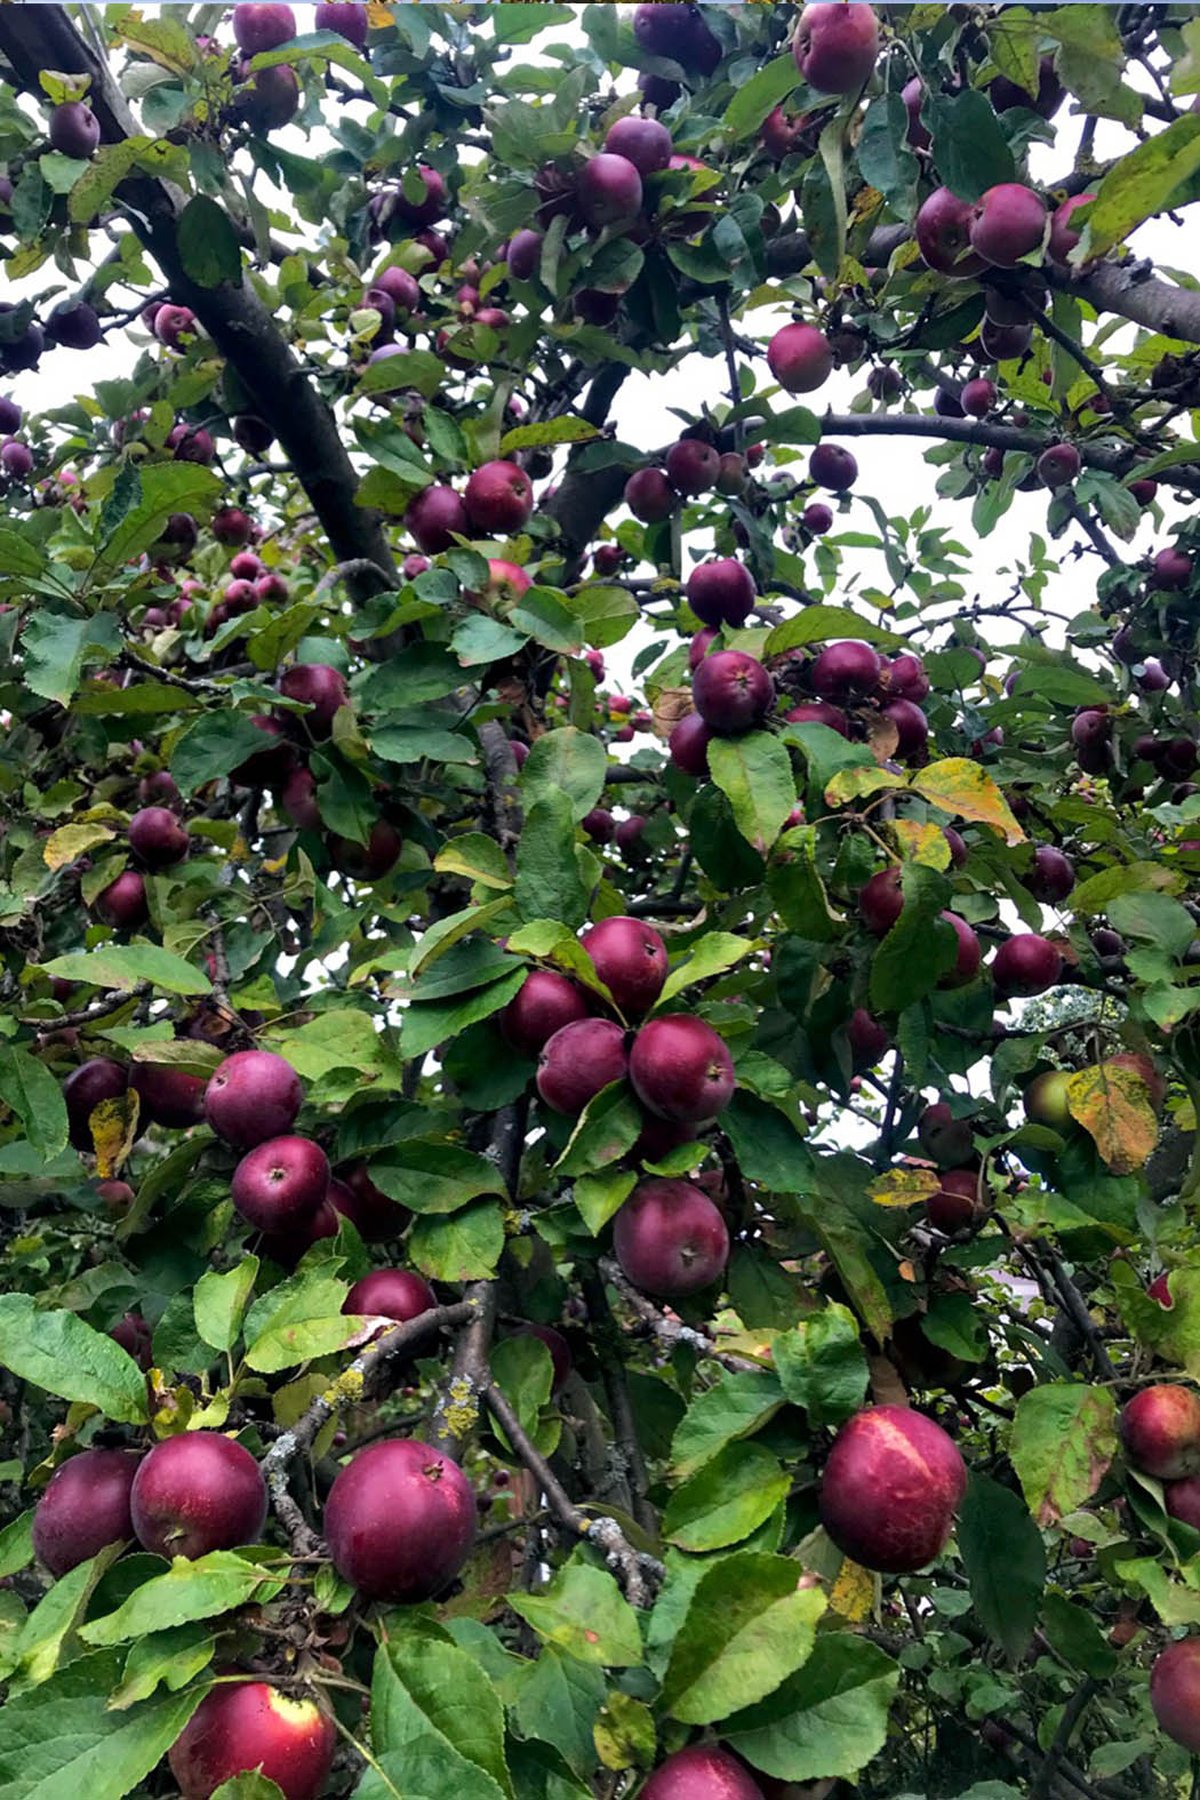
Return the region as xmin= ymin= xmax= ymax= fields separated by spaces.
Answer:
xmin=370 ymin=1627 xmax=513 ymax=1800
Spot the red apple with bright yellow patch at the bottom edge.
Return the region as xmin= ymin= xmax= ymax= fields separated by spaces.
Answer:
xmin=167 ymin=1670 xmax=338 ymax=1800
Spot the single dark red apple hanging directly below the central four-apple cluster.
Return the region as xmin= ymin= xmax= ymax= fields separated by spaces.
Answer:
xmin=613 ymin=1179 xmax=729 ymax=1300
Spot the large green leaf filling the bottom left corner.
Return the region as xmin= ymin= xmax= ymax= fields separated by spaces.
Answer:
xmin=0 ymin=1651 xmax=205 ymax=1800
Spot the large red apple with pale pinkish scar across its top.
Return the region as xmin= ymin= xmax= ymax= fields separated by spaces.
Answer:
xmin=820 ymin=1406 xmax=966 ymax=1575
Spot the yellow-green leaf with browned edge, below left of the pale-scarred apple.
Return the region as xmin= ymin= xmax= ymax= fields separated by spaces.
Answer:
xmin=660 ymin=1550 xmax=826 ymax=1724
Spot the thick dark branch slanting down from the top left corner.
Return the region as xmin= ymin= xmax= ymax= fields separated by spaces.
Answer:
xmin=0 ymin=5 xmax=398 ymax=596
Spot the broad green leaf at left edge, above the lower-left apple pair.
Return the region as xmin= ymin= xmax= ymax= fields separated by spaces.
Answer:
xmin=0 ymin=1294 xmax=149 ymax=1426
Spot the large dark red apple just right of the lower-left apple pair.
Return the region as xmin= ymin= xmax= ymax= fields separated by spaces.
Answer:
xmin=326 ymin=1438 xmax=475 ymax=1606
